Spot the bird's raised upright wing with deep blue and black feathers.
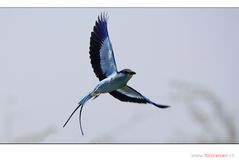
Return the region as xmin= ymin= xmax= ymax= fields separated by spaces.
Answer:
xmin=89 ymin=14 xmax=117 ymax=81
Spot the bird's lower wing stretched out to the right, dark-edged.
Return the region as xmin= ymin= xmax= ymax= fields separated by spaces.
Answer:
xmin=109 ymin=86 xmax=169 ymax=108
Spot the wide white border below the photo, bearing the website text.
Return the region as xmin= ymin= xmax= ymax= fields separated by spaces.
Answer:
xmin=0 ymin=144 xmax=239 ymax=167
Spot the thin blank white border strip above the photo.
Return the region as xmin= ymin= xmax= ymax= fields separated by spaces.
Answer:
xmin=0 ymin=0 xmax=239 ymax=7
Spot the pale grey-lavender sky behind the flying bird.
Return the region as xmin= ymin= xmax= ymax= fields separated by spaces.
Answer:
xmin=0 ymin=8 xmax=239 ymax=143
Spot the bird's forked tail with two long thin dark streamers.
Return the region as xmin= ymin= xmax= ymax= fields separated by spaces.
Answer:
xmin=63 ymin=92 xmax=93 ymax=135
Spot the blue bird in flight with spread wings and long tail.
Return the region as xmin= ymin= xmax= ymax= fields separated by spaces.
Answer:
xmin=63 ymin=13 xmax=169 ymax=135
